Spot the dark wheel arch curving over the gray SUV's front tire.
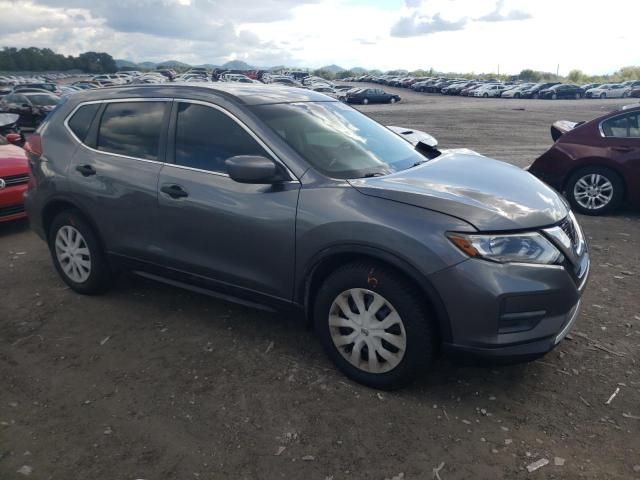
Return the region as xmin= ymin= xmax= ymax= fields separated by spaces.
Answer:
xmin=296 ymin=245 xmax=451 ymax=341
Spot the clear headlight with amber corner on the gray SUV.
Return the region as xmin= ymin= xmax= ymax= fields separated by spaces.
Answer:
xmin=447 ymin=232 xmax=562 ymax=264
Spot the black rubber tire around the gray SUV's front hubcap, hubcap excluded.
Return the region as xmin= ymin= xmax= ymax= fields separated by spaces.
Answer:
xmin=313 ymin=261 xmax=436 ymax=390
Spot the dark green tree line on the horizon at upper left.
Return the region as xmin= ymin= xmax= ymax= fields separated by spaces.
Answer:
xmin=0 ymin=47 xmax=117 ymax=73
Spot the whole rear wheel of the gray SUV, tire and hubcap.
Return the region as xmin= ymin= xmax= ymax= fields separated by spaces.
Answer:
xmin=49 ymin=211 xmax=111 ymax=295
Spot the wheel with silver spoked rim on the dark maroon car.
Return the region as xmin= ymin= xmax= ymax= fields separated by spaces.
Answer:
xmin=566 ymin=167 xmax=624 ymax=215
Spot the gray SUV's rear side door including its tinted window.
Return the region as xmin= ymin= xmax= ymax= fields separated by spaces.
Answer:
xmin=67 ymin=98 xmax=171 ymax=261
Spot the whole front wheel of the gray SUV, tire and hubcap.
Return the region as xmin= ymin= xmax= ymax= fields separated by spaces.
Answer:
xmin=314 ymin=262 xmax=435 ymax=390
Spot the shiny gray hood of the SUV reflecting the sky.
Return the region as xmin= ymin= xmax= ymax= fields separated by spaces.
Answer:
xmin=349 ymin=150 xmax=568 ymax=231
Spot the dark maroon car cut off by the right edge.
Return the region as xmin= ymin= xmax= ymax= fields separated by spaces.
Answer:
xmin=529 ymin=104 xmax=640 ymax=215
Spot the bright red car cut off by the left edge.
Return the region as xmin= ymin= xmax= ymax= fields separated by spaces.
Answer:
xmin=0 ymin=134 xmax=29 ymax=223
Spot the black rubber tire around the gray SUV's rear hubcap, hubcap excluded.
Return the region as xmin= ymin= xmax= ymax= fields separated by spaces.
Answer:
xmin=48 ymin=210 xmax=113 ymax=295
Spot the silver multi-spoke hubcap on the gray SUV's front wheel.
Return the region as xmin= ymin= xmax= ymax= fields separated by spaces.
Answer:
xmin=329 ymin=288 xmax=407 ymax=373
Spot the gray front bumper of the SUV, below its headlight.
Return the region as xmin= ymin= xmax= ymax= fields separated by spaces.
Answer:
xmin=430 ymin=248 xmax=589 ymax=361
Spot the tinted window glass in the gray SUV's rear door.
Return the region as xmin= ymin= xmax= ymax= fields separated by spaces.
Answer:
xmin=97 ymin=102 xmax=166 ymax=160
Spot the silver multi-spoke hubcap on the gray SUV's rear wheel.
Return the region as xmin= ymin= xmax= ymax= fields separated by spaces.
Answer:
xmin=55 ymin=225 xmax=91 ymax=283
